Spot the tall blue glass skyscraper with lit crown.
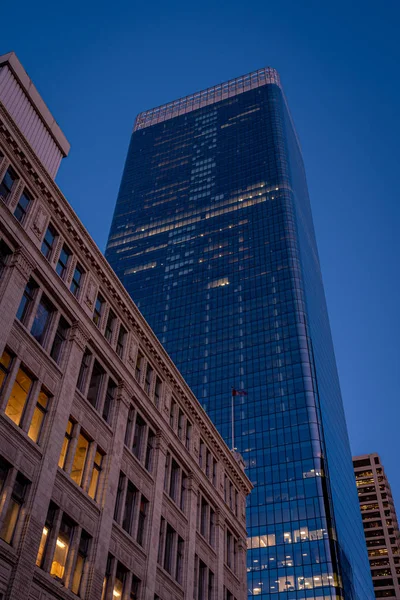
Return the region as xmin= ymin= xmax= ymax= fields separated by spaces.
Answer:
xmin=106 ymin=68 xmax=373 ymax=600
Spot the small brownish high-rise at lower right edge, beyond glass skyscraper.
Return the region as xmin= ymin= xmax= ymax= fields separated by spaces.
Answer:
xmin=353 ymin=454 xmax=400 ymax=600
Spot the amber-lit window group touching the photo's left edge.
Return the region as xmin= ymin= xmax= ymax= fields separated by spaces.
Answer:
xmin=0 ymin=349 xmax=51 ymax=444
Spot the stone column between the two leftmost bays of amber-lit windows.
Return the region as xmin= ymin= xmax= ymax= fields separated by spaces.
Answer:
xmin=6 ymin=323 xmax=89 ymax=600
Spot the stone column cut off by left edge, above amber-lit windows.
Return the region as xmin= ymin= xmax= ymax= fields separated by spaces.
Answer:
xmin=0 ymin=250 xmax=35 ymax=356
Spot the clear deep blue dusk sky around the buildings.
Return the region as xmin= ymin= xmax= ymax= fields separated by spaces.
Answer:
xmin=0 ymin=0 xmax=400 ymax=504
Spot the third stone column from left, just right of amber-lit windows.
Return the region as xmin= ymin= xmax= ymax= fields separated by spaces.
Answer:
xmin=86 ymin=382 xmax=133 ymax=600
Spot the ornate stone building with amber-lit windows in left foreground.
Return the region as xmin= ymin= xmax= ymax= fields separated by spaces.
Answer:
xmin=0 ymin=54 xmax=251 ymax=600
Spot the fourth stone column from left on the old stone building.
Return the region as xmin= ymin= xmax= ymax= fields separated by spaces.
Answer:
xmin=143 ymin=431 xmax=168 ymax=600
